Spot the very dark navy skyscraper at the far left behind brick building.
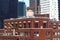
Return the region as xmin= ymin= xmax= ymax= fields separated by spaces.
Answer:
xmin=0 ymin=0 xmax=18 ymax=28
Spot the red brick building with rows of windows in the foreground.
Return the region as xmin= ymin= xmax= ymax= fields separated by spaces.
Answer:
xmin=0 ymin=14 xmax=60 ymax=40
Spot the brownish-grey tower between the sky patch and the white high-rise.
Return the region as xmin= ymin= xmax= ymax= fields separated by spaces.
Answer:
xmin=30 ymin=0 xmax=40 ymax=13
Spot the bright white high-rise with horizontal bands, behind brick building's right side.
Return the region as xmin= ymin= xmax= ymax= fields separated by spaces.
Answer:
xmin=40 ymin=0 xmax=58 ymax=20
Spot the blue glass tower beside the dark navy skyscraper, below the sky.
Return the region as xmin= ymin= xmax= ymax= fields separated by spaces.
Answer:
xmin=18 ymin=2 xmax=26 ymax=17
